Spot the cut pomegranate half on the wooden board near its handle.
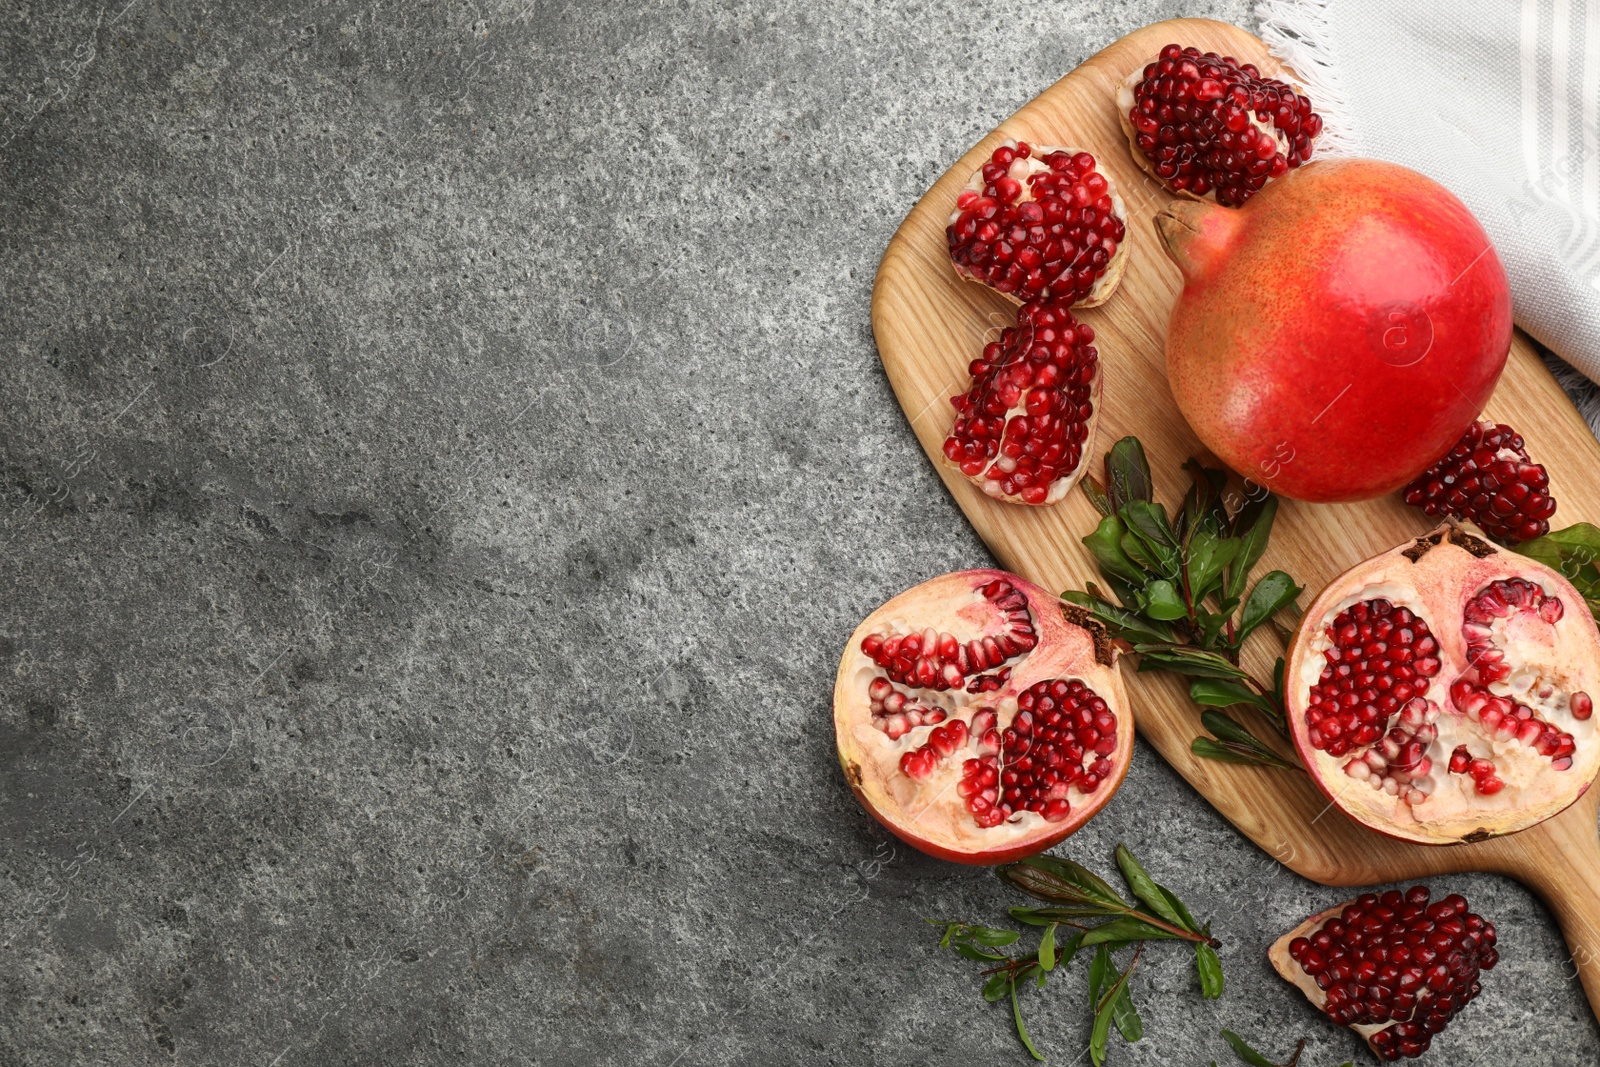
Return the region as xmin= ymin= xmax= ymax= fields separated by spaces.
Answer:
xmin=1285 ymin=525 xmax=1600 ymax=845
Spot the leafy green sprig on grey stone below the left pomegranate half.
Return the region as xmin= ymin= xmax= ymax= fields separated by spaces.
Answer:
xmin=928 ymin=845 xmax=1222 ymax=1067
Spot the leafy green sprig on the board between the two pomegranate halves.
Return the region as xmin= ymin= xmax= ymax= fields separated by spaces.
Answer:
xmin=1061 ymin=437 xmax=1302 ymax=768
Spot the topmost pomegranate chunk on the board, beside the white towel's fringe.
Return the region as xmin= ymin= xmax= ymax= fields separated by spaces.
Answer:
xmin=1117 ymin=45 xmax=1322 ymax=206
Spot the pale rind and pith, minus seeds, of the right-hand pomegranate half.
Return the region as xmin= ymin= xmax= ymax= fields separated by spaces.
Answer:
xmin=1285 ymin=523 xmax=1600 ymax=845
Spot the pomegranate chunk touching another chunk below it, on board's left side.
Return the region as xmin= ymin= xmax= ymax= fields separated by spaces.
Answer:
xmin=946 ymin=139 xmax=1128 ymax=307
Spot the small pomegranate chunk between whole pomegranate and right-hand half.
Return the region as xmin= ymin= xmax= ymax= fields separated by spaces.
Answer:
xmin=1405 ymin=422 xmax=1555 ymax=544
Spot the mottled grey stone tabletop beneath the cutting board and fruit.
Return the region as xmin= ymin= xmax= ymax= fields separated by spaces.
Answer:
xmin=0 ymin=0 xmax=1600 ymax=1067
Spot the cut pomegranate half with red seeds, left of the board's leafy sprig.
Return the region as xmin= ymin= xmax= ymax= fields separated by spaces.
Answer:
xmin=834 ymin=571 xmax=1133 ymax=865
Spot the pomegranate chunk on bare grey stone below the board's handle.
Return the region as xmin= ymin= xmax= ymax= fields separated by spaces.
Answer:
xmin=1267 ymin=886 xmax=1499 ymax=1059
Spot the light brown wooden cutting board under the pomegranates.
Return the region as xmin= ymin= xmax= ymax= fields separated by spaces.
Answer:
xmin=872 ymin=19 xmax=1600 ymax=1011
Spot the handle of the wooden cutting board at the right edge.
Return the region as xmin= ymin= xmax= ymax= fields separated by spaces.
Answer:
xmin=1504 ymin=798 xmax=1600 ymax=1016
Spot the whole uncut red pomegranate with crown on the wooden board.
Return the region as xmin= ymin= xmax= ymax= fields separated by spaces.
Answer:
xmin=1155 ymin=160 xmax=1512 ymax=502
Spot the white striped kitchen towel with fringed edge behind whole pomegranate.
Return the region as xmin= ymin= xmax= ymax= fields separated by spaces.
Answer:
xmin=1256 ymin=0 xmax=1600 ymax=404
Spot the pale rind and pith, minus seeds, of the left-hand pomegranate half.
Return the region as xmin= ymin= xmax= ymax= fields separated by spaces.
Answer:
xmin=834 ymin=569 xmax=1134 ymax=867
